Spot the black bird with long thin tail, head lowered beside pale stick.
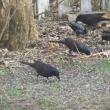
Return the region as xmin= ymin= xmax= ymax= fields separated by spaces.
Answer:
xmin=50 ymin=38 xmax=92 ymax=55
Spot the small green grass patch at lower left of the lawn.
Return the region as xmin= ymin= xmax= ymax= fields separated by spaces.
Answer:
xmin=6 ymin=86 xmax=22 ymax=96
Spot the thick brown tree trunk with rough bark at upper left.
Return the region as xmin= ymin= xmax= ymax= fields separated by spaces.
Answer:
xmin=0 ymin=0 xmax=38 ymax=50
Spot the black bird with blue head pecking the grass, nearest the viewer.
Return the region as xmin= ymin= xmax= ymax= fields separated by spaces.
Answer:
xmin=21 ymin=60 xmax=60 ymax=80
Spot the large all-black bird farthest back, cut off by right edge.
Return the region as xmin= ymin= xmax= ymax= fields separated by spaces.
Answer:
xmin=76 ymin=13 xmax=110 ymax=27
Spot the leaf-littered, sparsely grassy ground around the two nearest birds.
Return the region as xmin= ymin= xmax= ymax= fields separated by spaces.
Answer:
xmin=0 ymin=22 xmax=110 ymax=110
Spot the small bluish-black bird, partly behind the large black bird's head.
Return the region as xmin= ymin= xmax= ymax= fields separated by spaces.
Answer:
xmin=68 ymin=22 xmax=87 ymax=35
